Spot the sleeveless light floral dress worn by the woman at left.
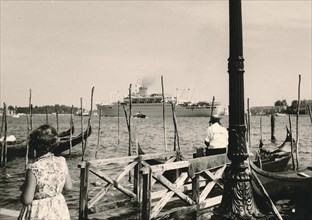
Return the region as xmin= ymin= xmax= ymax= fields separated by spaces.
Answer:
xmin=18 ymin=153 xmax=70 ymax=220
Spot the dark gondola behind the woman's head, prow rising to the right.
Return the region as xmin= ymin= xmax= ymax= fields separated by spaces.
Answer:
xmin=7 ymin=125 xmax=92 ymax=160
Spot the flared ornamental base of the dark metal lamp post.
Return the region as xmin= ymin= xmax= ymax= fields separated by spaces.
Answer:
xmin=212 ymin=164 xmax=266 ymax=220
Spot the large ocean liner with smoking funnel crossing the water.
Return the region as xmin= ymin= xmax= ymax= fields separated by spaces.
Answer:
xmin=97 ymin=86 xmax=221 ymax=117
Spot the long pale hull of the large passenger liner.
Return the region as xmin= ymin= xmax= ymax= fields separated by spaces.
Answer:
xmin=97 ymin=103 xmax=216 ymax=117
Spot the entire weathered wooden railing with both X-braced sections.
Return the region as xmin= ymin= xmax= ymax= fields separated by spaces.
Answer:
xmin=79 ymin=152 xmax=226 ymax=220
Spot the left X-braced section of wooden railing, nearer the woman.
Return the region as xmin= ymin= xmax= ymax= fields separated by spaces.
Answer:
xmin=78 ymin=152 xmax=178 ymax=219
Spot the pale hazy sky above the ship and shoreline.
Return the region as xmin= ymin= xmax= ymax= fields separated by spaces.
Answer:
xmin=0 ymin=0 xmax=312 ymax=109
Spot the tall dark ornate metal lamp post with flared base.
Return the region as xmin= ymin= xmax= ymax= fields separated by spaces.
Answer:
xmin=214 ymin=0 xmax=260 ymax=219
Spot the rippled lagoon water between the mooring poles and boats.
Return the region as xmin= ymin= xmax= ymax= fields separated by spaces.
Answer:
xmin=0 ymin=115 xmax=312 ymax=219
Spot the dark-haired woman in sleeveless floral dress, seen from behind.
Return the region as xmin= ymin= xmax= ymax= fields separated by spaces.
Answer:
xmin=18 ymin=125 xmax=72 ymax=220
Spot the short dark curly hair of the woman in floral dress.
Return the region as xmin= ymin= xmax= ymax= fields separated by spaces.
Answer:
xmin=28 ymin=124 xmax=59 ymax=154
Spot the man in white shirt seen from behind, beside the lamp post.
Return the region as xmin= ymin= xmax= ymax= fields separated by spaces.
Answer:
xmin=204 ymin=115 xmax=229 ymax=156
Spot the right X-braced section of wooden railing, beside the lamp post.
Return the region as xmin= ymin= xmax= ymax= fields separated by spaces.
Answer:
xmin=141 ymin=156 xmax=226 ymax=219
